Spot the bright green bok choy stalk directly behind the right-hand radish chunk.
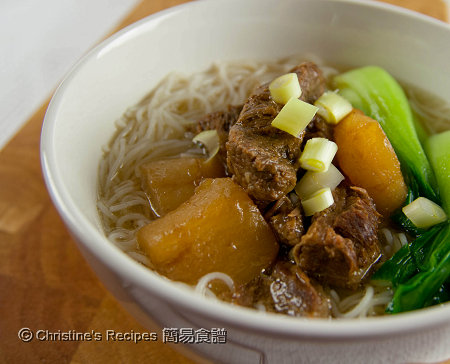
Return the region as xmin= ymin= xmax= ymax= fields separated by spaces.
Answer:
xmin=334 ymin=66 xmax=439 ymax=203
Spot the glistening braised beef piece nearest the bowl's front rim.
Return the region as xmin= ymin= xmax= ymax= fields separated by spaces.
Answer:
xmin=233 ymin=261 xmax=330 ymax=317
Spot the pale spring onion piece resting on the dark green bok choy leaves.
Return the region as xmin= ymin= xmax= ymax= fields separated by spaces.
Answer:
xmin=402 ymin=197 xmax=447 ymax=229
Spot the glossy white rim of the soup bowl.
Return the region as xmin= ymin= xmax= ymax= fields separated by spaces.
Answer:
xmin=40 ymin=0 xmax=450 ymax=340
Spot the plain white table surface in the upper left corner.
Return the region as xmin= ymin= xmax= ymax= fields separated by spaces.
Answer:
xmin=0 ymin=0 xmax=450 ymax=149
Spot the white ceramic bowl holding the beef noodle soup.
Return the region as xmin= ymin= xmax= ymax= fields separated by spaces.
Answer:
xmin=41 ymin=0 xmax=450 ymax=363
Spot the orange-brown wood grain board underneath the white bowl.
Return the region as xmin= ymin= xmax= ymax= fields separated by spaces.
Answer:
xmin=0 ymin=0 xmax=447 ymax=364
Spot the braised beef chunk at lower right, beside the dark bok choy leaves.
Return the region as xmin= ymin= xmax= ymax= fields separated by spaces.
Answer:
xmin=292 ymin=186 xmax=380 ymax=289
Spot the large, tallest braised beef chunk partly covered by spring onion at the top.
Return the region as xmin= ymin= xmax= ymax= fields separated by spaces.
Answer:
xmin=226 ymin=62 xmax=326 ymax=205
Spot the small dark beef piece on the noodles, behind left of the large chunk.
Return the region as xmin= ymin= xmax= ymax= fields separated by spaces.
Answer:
xmin=187 ymin=105 xmax=242 ymax=163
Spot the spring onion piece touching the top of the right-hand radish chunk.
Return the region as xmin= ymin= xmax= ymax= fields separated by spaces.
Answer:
xmin=314 ymin=91 xmax=353 ymax=124
